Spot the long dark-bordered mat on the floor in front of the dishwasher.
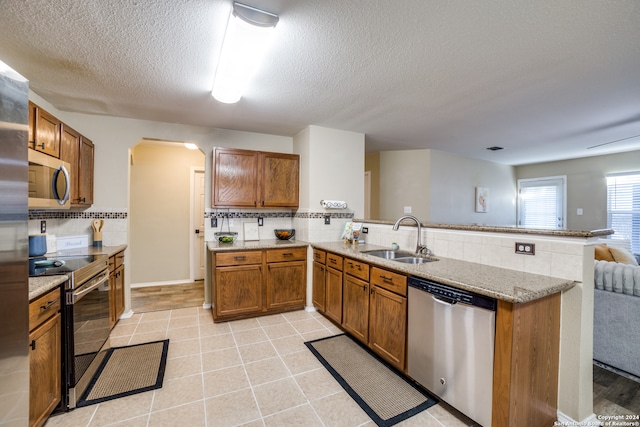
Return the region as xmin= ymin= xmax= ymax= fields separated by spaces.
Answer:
xmin=305 ymin=334 xmax=438 ymax=427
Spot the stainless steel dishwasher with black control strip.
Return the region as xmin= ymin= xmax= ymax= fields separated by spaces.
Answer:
xmin=407 ymin=277 xmax=496 ymax=426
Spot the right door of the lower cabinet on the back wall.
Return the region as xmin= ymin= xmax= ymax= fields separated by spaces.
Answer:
xmin=267 ymin=261 xmax=307 ymax=310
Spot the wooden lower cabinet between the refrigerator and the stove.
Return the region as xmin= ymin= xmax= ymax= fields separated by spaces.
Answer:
xmin=29 ymin=288 xmax=62 ymax=426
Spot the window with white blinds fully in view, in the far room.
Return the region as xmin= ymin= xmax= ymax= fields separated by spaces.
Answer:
xmin=518 ymin=176 xmax=567 ymax=230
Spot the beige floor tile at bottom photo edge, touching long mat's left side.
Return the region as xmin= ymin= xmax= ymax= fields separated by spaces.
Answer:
xmin=311 ymin=391 xmax=370 ymax=427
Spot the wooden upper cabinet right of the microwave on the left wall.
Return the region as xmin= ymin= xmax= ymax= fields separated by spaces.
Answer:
xmin=60 ymin=123 xmax=94 ymax=206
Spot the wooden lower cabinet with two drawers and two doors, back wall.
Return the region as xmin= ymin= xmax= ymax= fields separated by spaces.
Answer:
xmin=211 ymin=247 xmax=307 ymax=322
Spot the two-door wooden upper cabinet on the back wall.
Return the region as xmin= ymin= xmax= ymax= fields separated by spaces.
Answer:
xmin=211 ymin=147 xmax=300 ymax=208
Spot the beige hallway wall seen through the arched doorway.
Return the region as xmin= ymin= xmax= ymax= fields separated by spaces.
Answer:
xmin=127 ymin=140 xmax=205 ymax=294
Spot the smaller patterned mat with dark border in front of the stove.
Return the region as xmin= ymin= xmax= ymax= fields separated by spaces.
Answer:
xmin=77 ymin=340 xmax=169 ymax=407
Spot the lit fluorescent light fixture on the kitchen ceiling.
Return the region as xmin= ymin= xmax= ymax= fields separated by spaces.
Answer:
xmin=211 ymin=2 xmax=278 ymax=104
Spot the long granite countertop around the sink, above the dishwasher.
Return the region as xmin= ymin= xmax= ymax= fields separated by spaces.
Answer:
xmin=311 ymin=242 xmax=576 ymax=303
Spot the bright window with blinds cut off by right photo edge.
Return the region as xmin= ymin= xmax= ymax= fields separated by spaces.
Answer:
xmin=607 ymin=172 xmax=640 ymax=254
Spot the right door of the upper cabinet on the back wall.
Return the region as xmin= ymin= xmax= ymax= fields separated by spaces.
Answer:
xmin=260 ymin=153 xmax=300 ymax=207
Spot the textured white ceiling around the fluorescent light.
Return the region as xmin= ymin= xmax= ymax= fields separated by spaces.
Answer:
xmin=0 ymin=0 xmax=640 ymax=164
